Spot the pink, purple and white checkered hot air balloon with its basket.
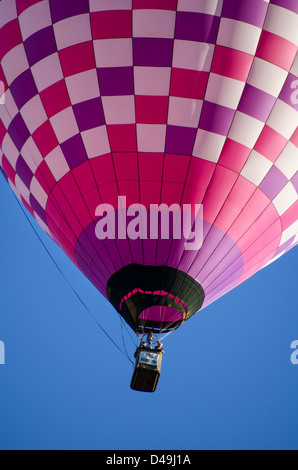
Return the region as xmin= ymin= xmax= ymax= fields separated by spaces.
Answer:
xmin=0 ymin=0 xmax=298 ymax=389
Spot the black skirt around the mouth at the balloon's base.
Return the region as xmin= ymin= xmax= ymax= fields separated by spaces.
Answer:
xmin=107 ymin=264 xmax=205 ymax=334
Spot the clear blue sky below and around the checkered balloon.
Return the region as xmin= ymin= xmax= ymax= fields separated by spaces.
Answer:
xmin=0 ymin=177 xmax=298 ymax=450
